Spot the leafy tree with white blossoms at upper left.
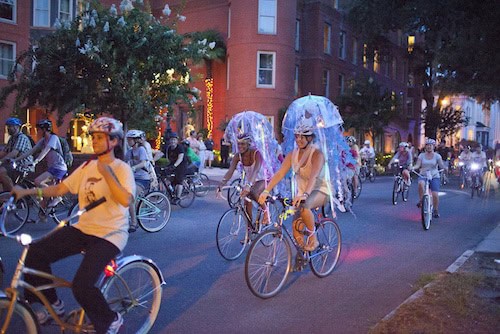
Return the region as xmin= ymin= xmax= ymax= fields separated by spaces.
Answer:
xmin=0 ymin=0 xmax=211 ymax=129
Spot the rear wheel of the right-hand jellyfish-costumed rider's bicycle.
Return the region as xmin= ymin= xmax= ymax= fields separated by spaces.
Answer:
xmin=309 ymin=218 xmax=342 ymax=278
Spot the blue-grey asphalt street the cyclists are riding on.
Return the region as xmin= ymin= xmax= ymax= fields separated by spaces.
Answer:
xmin=0 ymin=177 xmax=500 ymax=333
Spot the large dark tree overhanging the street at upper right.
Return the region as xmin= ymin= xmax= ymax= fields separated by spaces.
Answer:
xmin=349 ymin=0 xmax=500 ymax=138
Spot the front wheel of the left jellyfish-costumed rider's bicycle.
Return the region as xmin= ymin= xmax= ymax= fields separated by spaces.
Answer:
xmin=215 ymin=208 xmax=249 ymax=261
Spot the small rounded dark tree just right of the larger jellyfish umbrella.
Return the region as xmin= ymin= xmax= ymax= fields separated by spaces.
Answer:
xmin=335 ymin=77 xmax=400 ymax=137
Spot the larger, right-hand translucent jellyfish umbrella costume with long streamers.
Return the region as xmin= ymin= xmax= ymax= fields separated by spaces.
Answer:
xmin=282 ymin=95 xmax=356 ymax=213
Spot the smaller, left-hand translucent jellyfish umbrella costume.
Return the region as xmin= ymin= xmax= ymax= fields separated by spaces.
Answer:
xmin=224 ymin=111 xmax=281 ymax=192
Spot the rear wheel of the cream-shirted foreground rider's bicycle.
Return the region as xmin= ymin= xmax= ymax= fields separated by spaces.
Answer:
xmin=101 ymin=261 xmax=162 ymax=333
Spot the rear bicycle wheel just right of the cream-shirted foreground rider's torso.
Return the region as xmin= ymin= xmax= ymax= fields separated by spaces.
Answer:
xmin=136 ymin=191 xmax=172 ymax=233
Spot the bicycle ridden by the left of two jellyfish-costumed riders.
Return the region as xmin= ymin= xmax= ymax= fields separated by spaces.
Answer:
xmin=215 ymin=186 xmax=278 ymax=261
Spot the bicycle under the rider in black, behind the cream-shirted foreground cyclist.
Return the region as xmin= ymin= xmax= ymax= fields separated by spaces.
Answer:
xmin=156 ymin=167 xmax=196 ymax=208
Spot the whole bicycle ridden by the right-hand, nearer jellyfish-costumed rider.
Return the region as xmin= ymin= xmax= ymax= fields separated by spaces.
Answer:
xmin=245 ymin=198 xmax=342 ymax=299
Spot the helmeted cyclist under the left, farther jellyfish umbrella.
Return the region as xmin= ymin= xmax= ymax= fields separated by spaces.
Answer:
xmin=218 ymin=133 xmax=269 ymax=224
